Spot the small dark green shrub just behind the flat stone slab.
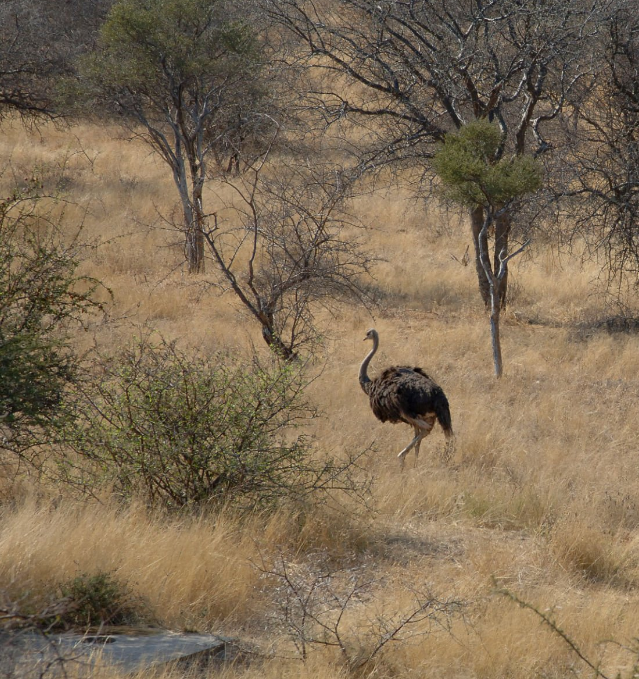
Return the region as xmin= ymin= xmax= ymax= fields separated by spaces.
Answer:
xmin=54 ymin=572 xmax=139 ymax=630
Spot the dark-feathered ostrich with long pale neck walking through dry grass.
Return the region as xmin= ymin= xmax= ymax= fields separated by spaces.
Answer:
xmin=359 ymin=328 xmax=453 ymax=469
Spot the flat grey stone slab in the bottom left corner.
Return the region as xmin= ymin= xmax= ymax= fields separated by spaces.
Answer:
xmin=0 ymin=631 xmax=236 ymax=673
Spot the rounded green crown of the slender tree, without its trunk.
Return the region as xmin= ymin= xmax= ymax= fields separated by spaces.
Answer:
xmin=433 ymin=120 xmax=542 ymax=208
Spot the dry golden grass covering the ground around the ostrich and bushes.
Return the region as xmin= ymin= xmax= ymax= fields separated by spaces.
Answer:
xmin=0 ymin=119 xmax=639 ymax=679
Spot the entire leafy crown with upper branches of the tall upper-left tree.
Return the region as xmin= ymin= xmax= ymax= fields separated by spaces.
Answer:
xmin=74 ymin=0 xmax=266 ymax=147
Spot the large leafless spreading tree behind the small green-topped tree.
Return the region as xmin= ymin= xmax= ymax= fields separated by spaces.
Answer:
xmin=264 ymin=0 xmax=606 ymax=306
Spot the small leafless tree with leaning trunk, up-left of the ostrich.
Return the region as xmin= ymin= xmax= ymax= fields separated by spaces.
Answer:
xmin=204 ymin=156 xmax=371 ymax=360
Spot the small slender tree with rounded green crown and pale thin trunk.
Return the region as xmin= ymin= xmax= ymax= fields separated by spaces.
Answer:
xmin=433 ymin=121 xmax=541 ymax=378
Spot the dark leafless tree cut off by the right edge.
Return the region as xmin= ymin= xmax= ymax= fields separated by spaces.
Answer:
xmin=564 ymin=0 xmax=639 ymax=292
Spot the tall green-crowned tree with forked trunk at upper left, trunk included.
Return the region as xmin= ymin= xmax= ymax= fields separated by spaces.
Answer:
xmin=75 ymin=0 xmax=273 ymax=273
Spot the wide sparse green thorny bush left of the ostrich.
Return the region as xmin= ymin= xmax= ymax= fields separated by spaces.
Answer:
xmin=60 ymin=340 xmax=360 ymax=508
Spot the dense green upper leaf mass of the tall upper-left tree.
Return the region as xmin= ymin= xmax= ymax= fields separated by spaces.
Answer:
xmin=89 ymin=0 xmax=259 ymax=111
